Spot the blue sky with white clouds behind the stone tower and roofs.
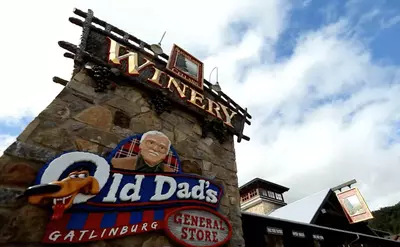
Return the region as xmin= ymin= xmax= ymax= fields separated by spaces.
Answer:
xmin=0 ymin=0 xmax=400 ymax=209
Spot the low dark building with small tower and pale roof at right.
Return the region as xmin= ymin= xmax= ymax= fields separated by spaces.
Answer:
xmin=240 ymin=178 xmax=400 ymax=247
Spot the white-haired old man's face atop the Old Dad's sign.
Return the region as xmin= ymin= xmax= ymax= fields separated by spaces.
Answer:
xmin=139 ymin=135 xmax=169 ymax=167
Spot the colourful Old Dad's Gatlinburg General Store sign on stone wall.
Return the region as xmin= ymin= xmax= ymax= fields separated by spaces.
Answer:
xmin=25 ymin=131 xmax=231 ymax=246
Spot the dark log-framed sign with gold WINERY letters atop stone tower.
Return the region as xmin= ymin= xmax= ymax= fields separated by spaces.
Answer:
xmin=59 ymin=9 xmax=251 ymax=142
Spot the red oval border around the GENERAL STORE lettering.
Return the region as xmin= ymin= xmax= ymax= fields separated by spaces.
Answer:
xmin=164 ymin=206 xmax=232 ymax=247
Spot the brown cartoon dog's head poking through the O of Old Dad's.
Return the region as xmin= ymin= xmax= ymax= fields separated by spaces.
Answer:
xmin=24 ymin=170 xmax=99 ymax=220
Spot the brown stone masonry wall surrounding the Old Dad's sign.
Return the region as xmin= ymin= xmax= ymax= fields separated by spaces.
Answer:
xmin=0 ymin=71 xmax=244 ymax=247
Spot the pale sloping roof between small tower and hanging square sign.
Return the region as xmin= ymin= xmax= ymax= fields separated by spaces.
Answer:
xmin=268 ymin=189 xmax=333 ymax=224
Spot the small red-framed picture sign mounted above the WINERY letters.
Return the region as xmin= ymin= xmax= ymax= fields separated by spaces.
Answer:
xmin=167 ymin=44 xmax=204 ymax=91
